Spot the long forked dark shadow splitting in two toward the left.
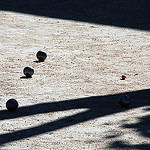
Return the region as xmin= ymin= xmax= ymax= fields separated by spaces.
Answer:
xmin=0 ymin=89 xmax=150 ymax=147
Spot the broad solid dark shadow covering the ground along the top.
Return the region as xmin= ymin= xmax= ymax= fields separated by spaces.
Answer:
xmin=0 ymin=0 xmax=150 ymax=30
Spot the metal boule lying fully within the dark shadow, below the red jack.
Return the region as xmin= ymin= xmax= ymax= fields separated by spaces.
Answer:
xmin=119 ymin=94 xmax=131 ymax=107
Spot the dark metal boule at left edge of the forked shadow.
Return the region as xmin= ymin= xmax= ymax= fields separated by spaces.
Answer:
xmin=6 ymin=99 xmax=18 ymax=112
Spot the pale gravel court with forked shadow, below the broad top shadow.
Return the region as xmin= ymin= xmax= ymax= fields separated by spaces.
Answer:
xmin=0 ymin=11 xmax=150 ymax=150
